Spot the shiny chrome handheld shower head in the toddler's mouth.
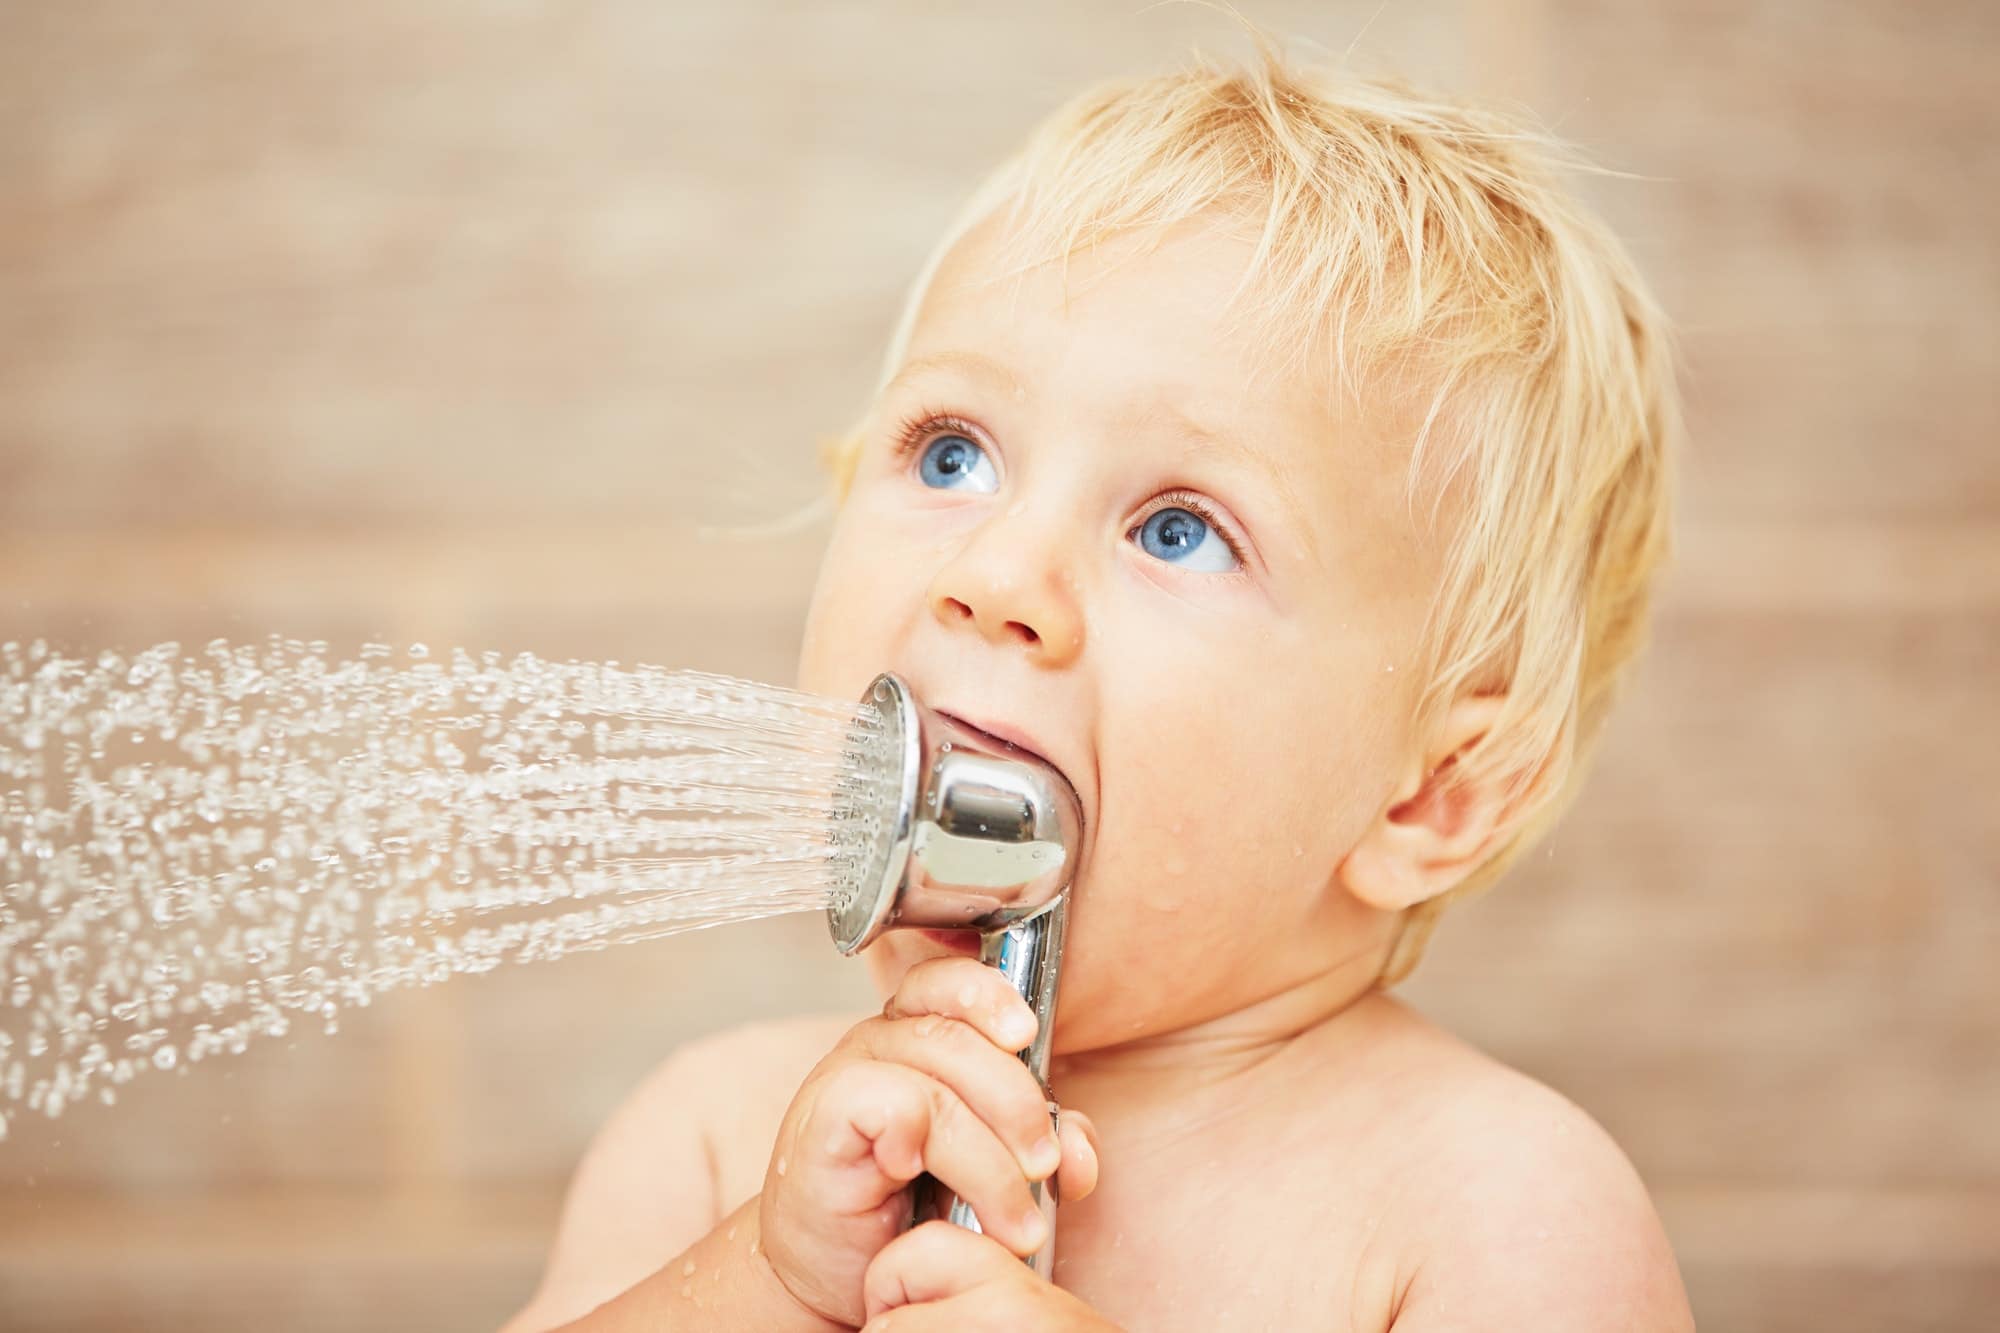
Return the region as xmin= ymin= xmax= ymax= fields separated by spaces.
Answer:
xmin=826 ymin=673 xmax=1084 ymax=1277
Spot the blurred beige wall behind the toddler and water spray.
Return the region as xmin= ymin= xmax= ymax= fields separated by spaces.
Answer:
xmin=0 ymin=0 xmax=2000 ymax=1331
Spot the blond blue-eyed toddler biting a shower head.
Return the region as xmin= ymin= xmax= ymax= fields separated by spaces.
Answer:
xmin=510 ymin=31 xmax=1692 ymax=1333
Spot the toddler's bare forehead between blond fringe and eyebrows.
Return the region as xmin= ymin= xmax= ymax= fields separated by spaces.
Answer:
xmin=890 ymin=216 xmax=1426 ymax=510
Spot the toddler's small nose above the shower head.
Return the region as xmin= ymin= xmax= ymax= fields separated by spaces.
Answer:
xmin=930 ymin=504 xmax=1084 ymax=667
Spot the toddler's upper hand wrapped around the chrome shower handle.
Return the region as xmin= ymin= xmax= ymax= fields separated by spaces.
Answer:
xmin=758 ymin=957 xmax=1098 ymax=1325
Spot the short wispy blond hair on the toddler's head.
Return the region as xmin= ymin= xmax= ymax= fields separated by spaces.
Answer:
xmin=822 ymin=28 xmax=1680 ymax=985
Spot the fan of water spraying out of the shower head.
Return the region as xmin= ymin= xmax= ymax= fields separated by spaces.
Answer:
xmin=0 ymin=636 xmax=884 ymax=1113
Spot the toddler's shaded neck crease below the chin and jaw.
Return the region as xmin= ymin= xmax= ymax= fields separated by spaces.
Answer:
xmin=1050 ymin=915 xmax=1396 ymax=1115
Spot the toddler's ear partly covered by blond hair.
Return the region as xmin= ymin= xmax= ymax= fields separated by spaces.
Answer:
xmin=1336 ymin=695 xmax=1508 ymax=913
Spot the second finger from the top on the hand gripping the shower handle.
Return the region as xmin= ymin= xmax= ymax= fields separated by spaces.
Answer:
xmin=852 ymin=1000 xmax=1062 ymax=1181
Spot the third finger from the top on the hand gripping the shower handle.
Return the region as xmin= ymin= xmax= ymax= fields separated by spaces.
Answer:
xmin=806 ymin=1061 xmax=1048 ymax=1255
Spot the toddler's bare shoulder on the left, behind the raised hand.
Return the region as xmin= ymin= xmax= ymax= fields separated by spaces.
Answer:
xmin=508 ymin=1015 xmax=856 ymax=1331
